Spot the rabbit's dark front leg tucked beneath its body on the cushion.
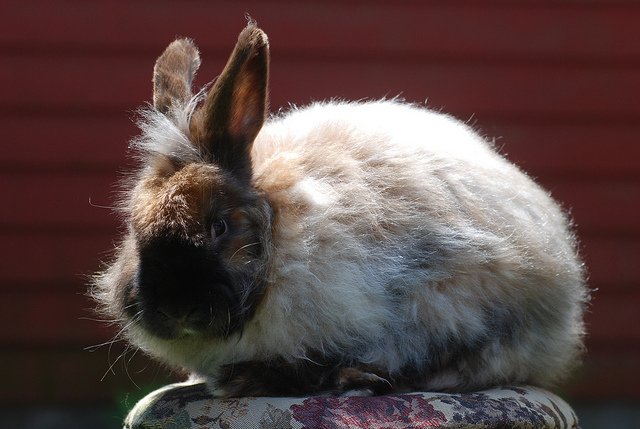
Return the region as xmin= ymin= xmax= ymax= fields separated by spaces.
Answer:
xmin=209 ymin=360 xmax=393 ymax=398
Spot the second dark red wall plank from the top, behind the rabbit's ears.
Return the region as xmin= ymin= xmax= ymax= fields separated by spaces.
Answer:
xmin=0 ymin=54 xmax=640 ymax=120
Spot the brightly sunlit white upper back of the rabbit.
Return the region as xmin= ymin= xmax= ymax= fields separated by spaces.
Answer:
xmin=252 ymin=101 xmax=576 ymax=274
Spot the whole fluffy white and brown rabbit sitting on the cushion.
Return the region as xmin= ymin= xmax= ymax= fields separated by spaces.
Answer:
xmin=91 ymin=22 xmax=589 ymax=398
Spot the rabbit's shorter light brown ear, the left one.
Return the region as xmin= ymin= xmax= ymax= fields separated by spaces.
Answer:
xmin=153 ymin=39 xmax=200 ymax=113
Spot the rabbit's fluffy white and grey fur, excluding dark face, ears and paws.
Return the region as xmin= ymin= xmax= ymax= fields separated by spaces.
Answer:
xmin=117 ymin=100 xmax=587 ymax=389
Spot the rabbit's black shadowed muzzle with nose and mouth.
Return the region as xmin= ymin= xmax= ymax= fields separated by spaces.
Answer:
xmin=126 ymin=236 xmax=242 ymax=339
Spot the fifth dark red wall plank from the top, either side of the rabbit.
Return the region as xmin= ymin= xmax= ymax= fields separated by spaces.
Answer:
xmin=0 ymin=230 xmax=640 ymax=290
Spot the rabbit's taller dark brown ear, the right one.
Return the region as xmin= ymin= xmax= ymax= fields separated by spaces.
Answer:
xmin=191 ymin=23 xmax=269 ymax=179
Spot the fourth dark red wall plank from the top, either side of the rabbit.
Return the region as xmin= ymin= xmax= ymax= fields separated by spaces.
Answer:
xmin=0 ymin=171 xmax=640 ymax=236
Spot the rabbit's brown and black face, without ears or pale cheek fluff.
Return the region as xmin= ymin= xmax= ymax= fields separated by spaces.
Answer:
xmin=123 ymin=164 xmax=270 ymax=338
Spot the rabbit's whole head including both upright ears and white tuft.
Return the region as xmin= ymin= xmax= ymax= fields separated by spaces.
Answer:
xmin=96 ymin=23 xmax=271 ymax=339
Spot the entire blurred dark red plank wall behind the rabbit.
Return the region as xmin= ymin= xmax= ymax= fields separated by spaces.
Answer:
xmin=0 ymin=0 xmax=640 ymax=429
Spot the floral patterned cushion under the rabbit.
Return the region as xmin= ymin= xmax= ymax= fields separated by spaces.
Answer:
xmin=125 ymin=383 xmax=578 ymax=429
